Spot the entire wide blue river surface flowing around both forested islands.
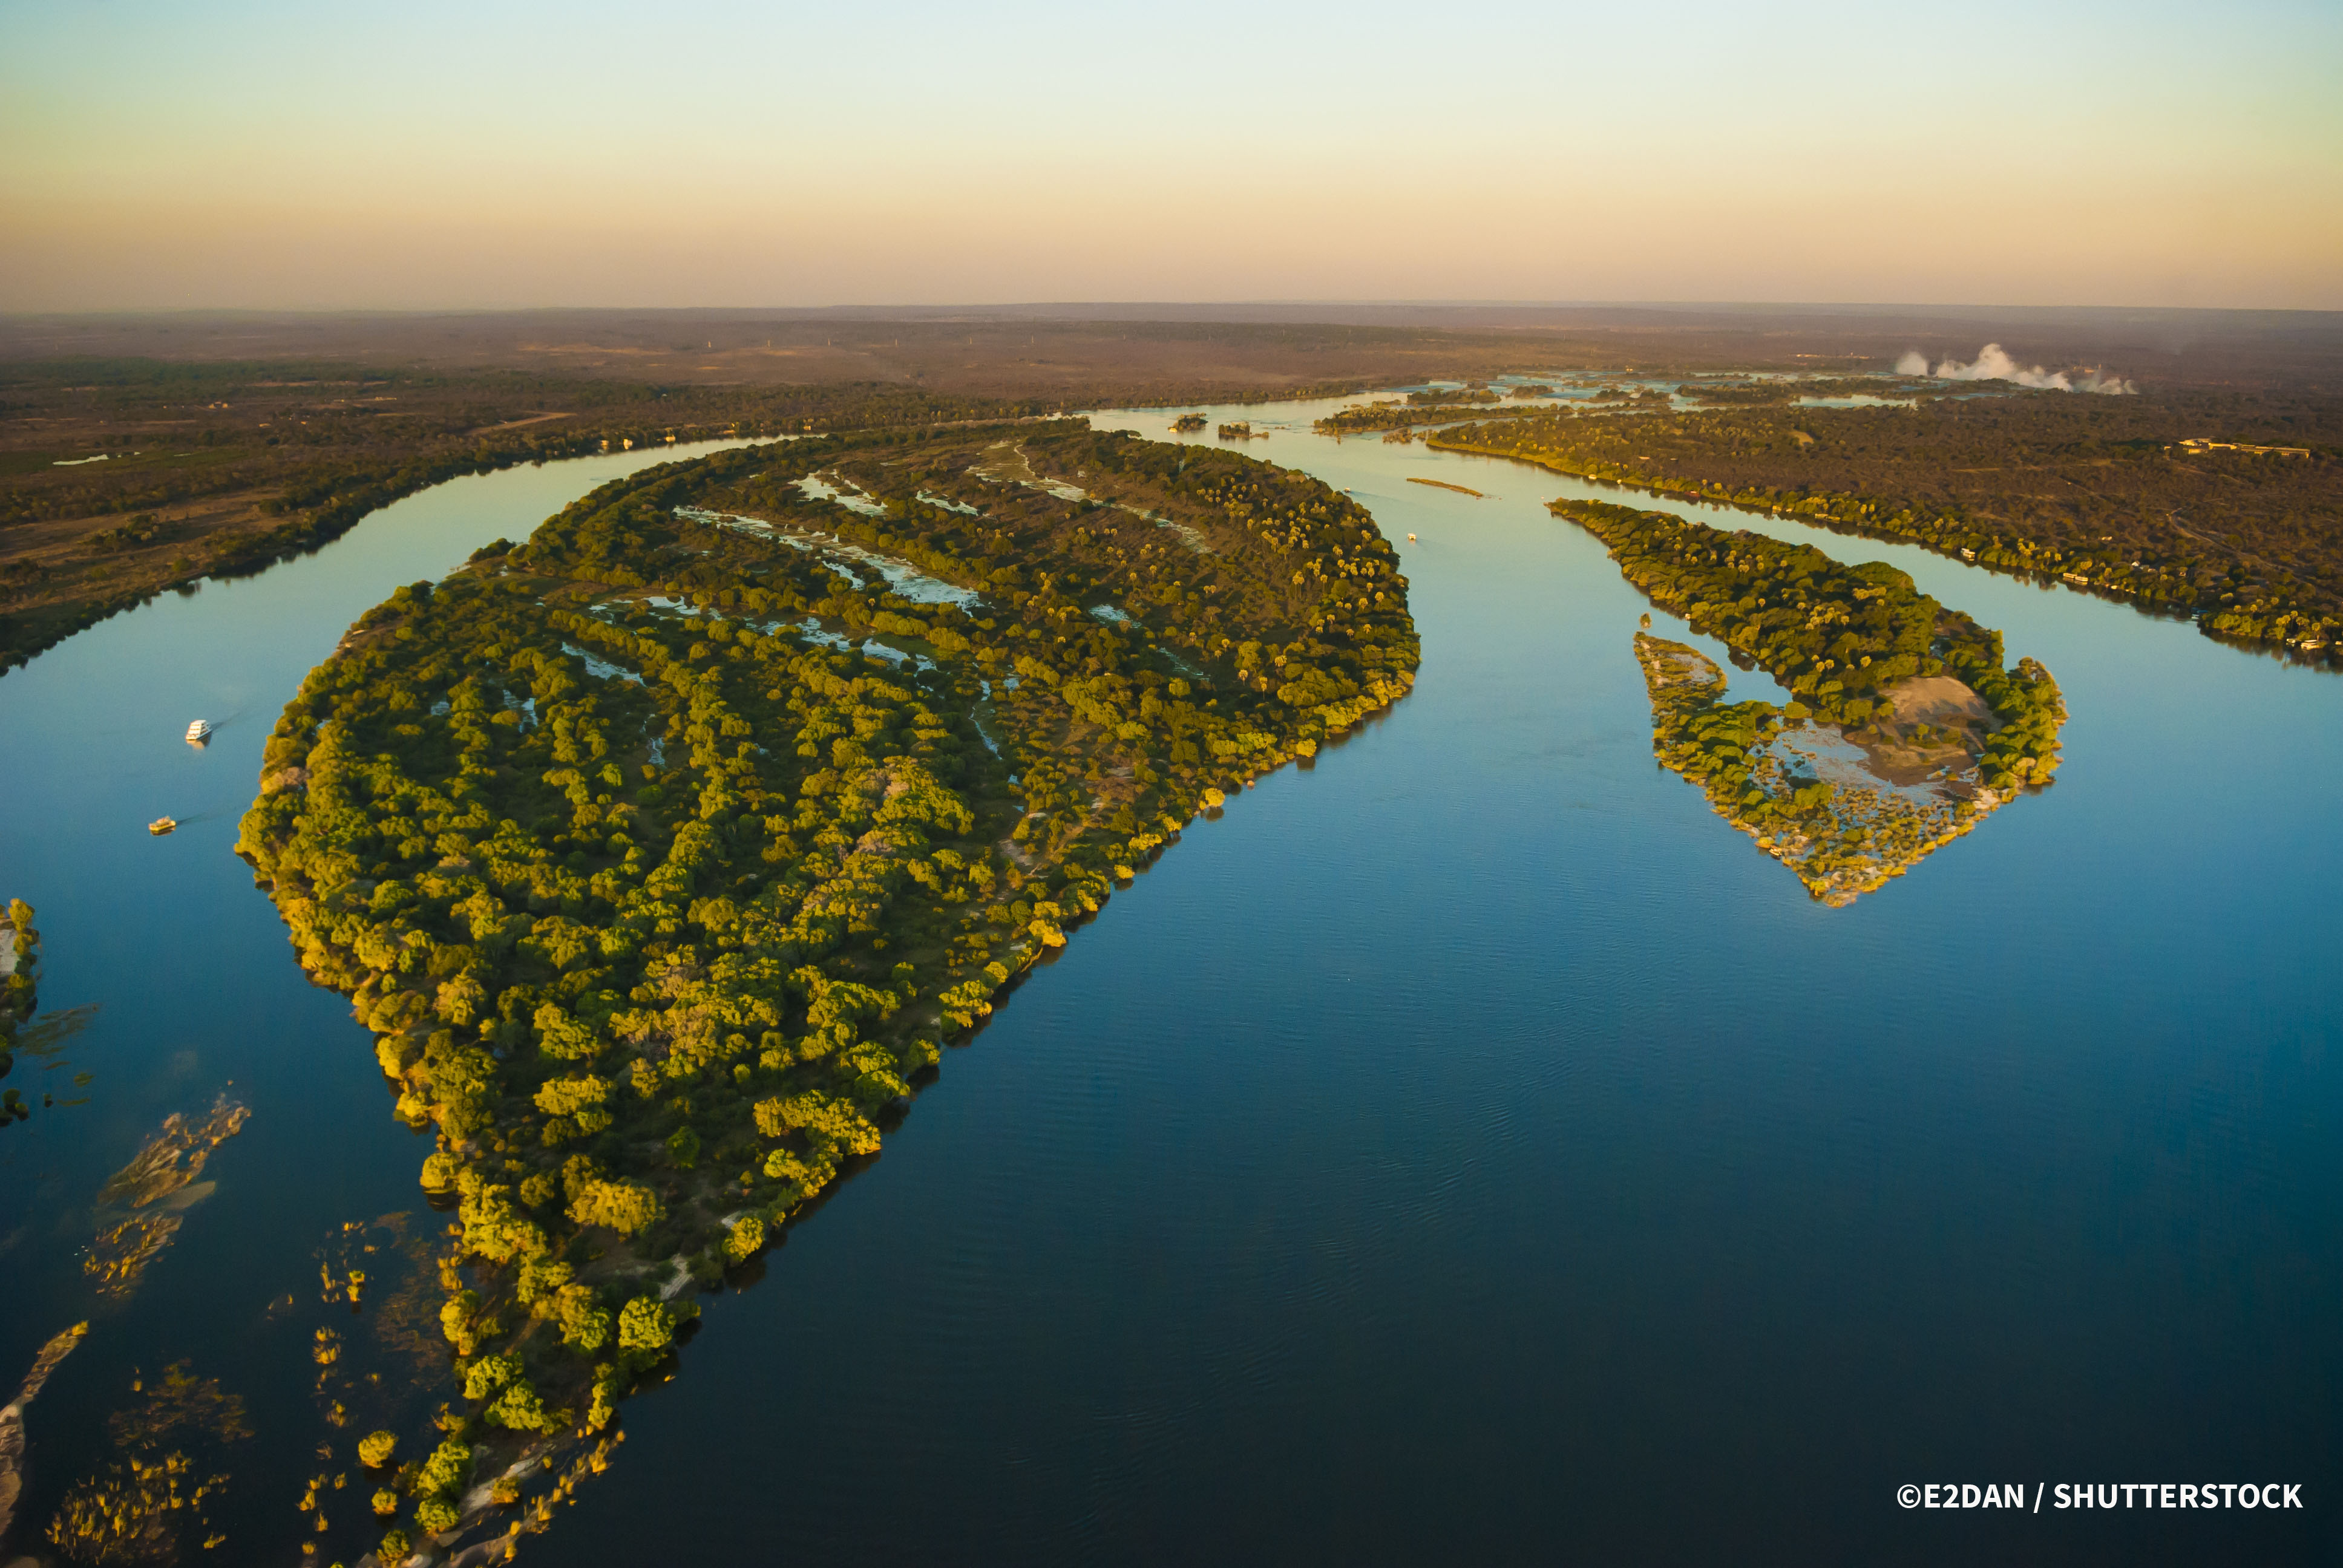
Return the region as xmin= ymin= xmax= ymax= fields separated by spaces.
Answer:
xmin=0 ymin=403 xmax=2343 ymax=1568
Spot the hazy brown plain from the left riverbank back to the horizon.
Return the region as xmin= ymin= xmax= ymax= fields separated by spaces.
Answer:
xmin=0 ymin=305 xmax=2343 ymax=668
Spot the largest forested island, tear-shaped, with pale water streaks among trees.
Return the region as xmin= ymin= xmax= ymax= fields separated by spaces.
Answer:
xmin=241 ymin=412 xmax=1418 ymax=1561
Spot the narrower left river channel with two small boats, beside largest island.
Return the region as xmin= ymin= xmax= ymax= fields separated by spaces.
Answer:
xmin=0 ymin=443 xmax=731 ymax=1563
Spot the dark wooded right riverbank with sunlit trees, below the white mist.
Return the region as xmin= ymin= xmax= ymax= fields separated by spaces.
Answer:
xmin=1424 ymin=391 xmax=2343 ymax=661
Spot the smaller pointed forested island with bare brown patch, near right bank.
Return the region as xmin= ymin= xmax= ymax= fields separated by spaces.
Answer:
xmin=1551 ymin=499 xmax=2066 ymax=905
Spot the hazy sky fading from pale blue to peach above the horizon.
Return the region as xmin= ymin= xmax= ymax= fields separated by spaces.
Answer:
xmin=0 ymin=0 xmax=2343 ymax=309
